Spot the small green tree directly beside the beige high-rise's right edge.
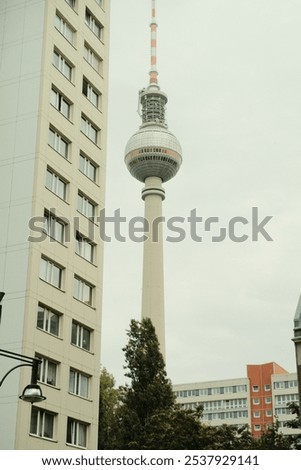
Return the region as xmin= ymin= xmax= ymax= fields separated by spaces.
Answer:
xmin=98 ymin=368 xmax=120 ymax=450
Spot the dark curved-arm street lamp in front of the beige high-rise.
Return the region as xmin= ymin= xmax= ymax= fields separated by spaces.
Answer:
xmin=0 ymin=349 xmax=46 ymax=403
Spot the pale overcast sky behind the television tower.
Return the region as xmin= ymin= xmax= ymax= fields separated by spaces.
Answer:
xmin=102 ymin=0 xmax=301 ymax=384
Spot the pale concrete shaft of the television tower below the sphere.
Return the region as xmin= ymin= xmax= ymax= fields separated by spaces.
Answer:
xmin=141 ymin=177 xmax=165 ymax=359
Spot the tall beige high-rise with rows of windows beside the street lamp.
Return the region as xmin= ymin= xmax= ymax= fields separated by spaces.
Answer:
xmin=0 ymin=0 xmax=110 ymax=449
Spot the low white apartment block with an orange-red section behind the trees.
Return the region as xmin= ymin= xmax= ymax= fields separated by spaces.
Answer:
xmin=173 ymin=362 xmax=299 ymax=437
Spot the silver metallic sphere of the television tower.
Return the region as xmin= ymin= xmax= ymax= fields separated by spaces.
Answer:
xmin=125 ymin=123 xmax=182 ymax=183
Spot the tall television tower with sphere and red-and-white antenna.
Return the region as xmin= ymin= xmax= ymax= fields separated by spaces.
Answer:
xmin=125 ymin=0 xmax=182 ymax=359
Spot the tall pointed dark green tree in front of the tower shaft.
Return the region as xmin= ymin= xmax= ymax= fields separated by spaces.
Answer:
xmin=113 ymin=319 xmax=207 ymax=450
